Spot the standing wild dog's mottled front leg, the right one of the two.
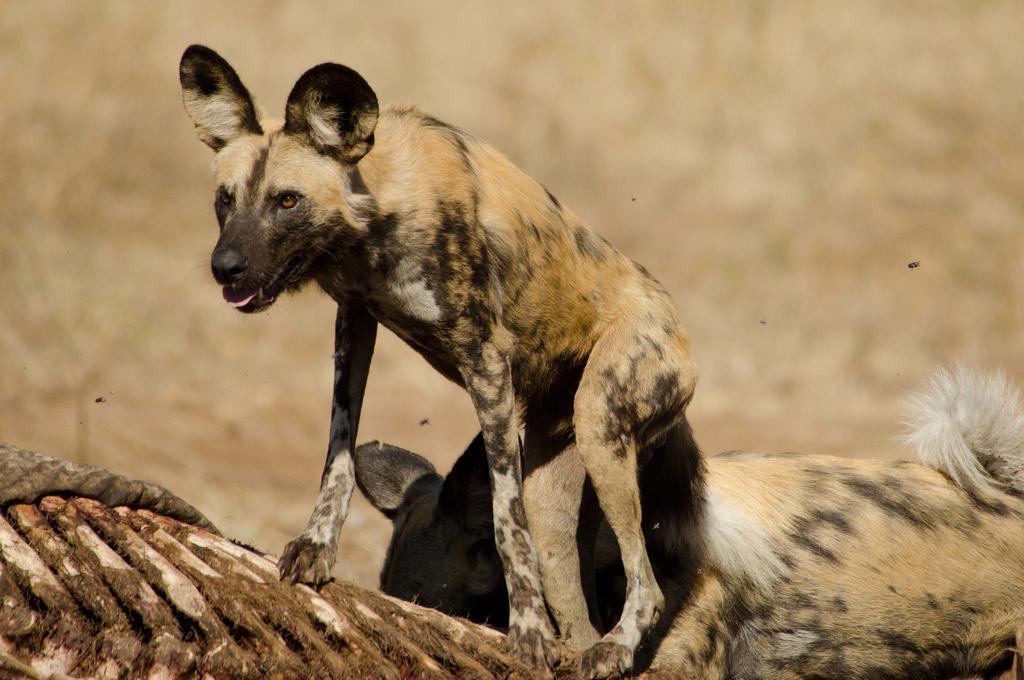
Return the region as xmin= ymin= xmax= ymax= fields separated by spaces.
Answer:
xmin=463 ymin=344 xmax=557 ymax=668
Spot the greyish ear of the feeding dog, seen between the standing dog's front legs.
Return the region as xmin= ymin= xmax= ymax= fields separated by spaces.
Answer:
xmin=352 ymin=441 xmax=441 ymax=519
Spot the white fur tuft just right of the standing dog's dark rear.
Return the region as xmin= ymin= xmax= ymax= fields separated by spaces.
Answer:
xmin=702 ymin=486 xmax=784 ymax=588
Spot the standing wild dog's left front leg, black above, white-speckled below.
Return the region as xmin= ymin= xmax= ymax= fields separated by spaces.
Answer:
xmin=279 ymin=304 xmax=377 ymax=586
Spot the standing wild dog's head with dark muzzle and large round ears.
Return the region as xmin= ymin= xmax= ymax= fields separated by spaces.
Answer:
xmin=179 ymin=45 xmax=378 ymax=312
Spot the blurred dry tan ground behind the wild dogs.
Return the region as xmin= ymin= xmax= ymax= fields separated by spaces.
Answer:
xmin=0 ymin=0 xmax=1024 ymax=585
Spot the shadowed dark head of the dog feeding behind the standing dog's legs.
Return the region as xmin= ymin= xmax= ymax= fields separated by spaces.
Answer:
xmin=355 ymin=435 xmax=508 ymax=627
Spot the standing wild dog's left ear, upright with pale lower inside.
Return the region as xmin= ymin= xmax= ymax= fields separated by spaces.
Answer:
xmin=178 ymin=45 xmax=263 ymax=152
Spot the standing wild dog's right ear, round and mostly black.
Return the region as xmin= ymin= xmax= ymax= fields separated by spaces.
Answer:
xmin=285 ymin=63 xmax=379 ymax=164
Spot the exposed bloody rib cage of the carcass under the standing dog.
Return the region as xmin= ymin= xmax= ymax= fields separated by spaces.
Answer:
xmin=0 ymin=445 xmax=552 ymax=678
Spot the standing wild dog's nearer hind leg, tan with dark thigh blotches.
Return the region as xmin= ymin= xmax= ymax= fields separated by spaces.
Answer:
xmin=573 ymin=323 xmax=696 ymax=677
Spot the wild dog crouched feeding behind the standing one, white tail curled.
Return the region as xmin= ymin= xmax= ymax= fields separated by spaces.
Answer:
xmin=355 ymin=372 xmax=1024 ymax=679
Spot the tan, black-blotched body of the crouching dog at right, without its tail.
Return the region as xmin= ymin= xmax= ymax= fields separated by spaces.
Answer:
xmin=700 ymin=454 xmax=1024 ymax=678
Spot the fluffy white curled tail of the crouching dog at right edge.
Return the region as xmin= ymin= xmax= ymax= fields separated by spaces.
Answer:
xmin=905 ymin=366 xmax=1024 ymax=492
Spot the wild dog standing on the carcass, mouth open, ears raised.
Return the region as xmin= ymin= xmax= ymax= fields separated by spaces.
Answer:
xmin=180 ymin=45 xmax=697 ymax=676
